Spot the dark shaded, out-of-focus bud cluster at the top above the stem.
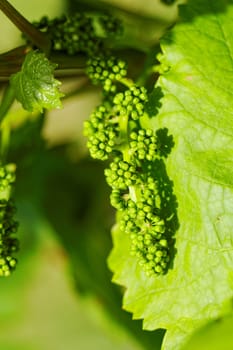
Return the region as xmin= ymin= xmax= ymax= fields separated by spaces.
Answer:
xmin=25 ymin=12 xmax=123 ymax=57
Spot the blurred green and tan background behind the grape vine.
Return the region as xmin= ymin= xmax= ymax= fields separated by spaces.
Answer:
xmin=0 ymin=0 xmax=184 ymax=350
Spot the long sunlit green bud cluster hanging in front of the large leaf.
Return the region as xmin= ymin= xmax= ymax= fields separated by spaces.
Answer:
xmin=84 ymin=52 xmax=170 ymax=276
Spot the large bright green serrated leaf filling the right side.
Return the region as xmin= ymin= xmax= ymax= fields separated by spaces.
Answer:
xmin=109 ymin=0 xmax=233 ymax=350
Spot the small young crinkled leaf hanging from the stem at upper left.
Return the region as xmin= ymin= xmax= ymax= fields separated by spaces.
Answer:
xmin=10 ymin=51 xmax=63 ymax=112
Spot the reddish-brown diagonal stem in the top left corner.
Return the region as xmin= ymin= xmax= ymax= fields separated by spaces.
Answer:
xmin=0 ymin=0 xmax=51 ymax=55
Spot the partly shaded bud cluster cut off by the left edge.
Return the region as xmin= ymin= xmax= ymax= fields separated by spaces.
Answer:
xmin=0 ymin=164 xmax=19 ymax=276
